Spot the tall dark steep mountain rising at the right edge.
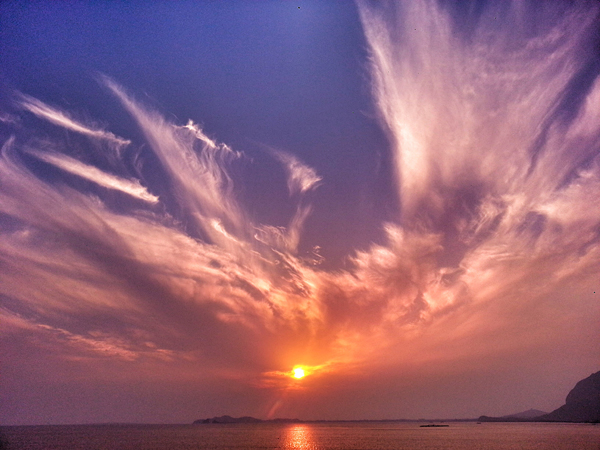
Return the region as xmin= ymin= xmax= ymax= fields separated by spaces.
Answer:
xmin=536 ymin=372 xmax=600 ymax=423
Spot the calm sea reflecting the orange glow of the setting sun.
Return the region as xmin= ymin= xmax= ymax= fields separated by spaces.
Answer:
xmin=0 ymin=423 xmax=600 ymax=450
